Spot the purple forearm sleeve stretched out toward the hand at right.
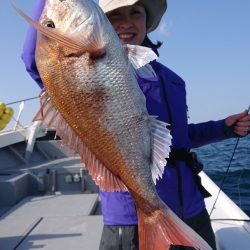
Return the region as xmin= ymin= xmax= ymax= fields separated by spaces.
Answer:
xmin=188 ymin=119 xmax=229 ymax=148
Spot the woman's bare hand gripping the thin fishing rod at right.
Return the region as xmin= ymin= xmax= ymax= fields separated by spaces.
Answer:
xmin=225 ymin=110 xmax=250 ymax=136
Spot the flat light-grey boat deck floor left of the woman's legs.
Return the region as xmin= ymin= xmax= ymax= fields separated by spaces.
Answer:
xmin=0 ymin=193 xmax=103 ymax=250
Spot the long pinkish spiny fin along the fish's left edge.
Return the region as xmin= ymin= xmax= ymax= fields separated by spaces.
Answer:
xmin=33 ymin=90 xmax=128 ymax=192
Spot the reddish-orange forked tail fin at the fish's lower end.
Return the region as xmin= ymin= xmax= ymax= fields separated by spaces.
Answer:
xmin=138 ymin=207 xmax=212 ymax=250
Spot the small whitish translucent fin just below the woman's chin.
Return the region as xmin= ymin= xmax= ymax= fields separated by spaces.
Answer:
xmin=124 ymin=44 xmax=157 ymax=71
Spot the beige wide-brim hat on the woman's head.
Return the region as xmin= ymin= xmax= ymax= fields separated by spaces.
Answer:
xmin=99 ymin=0 xmax=167 ymax=33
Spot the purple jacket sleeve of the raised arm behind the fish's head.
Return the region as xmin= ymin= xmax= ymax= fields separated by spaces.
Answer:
xmin=21 ymin=0 xmax=45 ymax=88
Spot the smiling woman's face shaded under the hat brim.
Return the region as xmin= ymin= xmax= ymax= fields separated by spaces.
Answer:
xmin=107 ymin=3 xmax=147 ymax=45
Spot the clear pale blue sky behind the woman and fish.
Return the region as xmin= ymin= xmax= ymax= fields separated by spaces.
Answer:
xmin=0 ymin=0 xmax=250 ymax=131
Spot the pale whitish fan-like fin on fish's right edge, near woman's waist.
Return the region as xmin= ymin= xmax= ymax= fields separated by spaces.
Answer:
xmin=150 ymin=116 xmax=172 ymax=183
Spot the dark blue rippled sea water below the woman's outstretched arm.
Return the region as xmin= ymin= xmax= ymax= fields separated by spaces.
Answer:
xmin=194 ymin=135 xmax=250 ymax=216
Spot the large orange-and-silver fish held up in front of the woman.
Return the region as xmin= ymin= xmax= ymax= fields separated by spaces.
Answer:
xmin=15 ymin=0 xmax=211 ymax=250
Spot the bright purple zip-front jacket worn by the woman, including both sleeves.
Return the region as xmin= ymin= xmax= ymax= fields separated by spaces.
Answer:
xmin=22 ymin=0 xmax=227 ymax=225
